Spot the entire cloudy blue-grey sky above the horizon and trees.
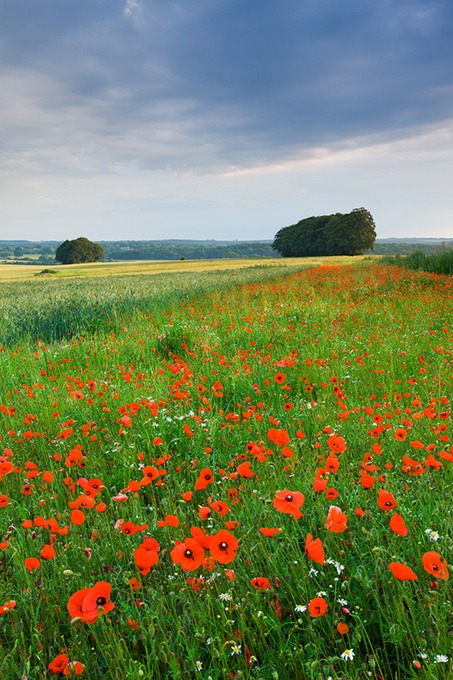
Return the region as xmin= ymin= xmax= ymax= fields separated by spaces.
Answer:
xmin=0 ymin=0 xmax=453 ymax=241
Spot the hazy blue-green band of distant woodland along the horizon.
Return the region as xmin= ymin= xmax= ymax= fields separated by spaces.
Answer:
xmin=0 ymin=238 xmax=453 ymax=265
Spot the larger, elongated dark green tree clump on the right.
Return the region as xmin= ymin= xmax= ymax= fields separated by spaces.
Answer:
xmin=272 ymin=208 xmax=376 ymax=257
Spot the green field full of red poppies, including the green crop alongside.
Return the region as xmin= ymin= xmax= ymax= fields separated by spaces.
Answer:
xmin=0 ymin=258 xmax=453 ymax=680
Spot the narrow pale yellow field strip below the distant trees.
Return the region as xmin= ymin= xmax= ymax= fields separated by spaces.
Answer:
xmin=0 ymin=256 xmax=370 ymax=282
